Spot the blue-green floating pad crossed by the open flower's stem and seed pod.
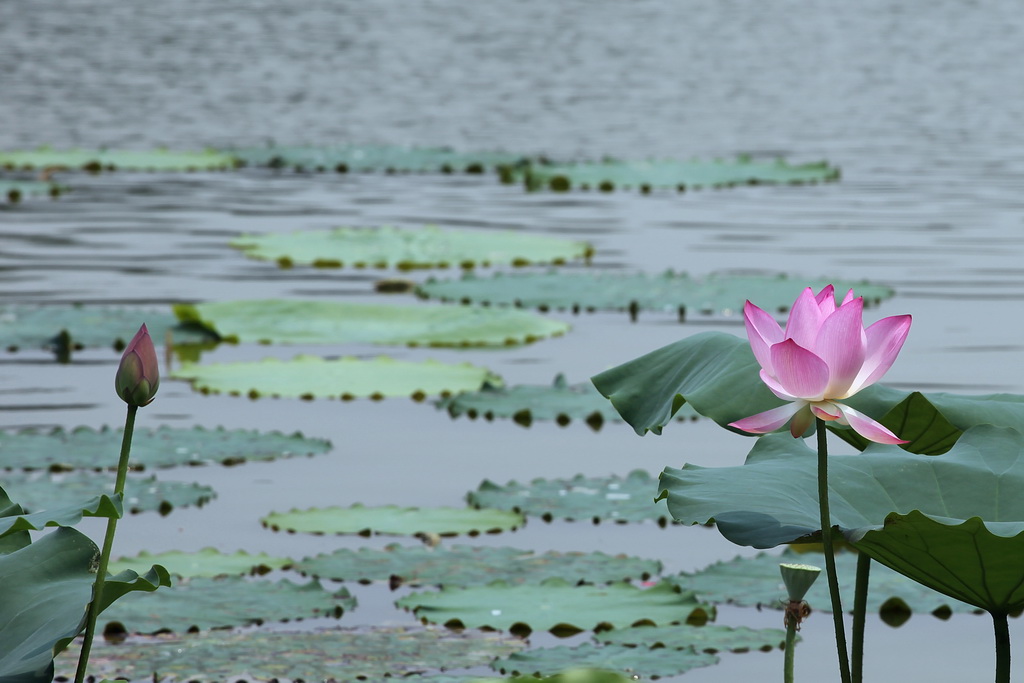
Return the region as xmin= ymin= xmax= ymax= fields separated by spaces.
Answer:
xmin=676 ymin=550 xmax=977 ymax=616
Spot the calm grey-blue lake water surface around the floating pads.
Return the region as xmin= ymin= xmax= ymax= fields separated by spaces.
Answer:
xmin=0 ymin=0 xmax=1024 ymax=682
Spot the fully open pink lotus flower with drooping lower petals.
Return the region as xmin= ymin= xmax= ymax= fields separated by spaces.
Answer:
xmin=729 ymin=285 xmax=910 ymax=443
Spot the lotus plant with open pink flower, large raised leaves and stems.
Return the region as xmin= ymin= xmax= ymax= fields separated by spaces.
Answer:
xmin=593 ymin=287 xmax=1024 ymax=683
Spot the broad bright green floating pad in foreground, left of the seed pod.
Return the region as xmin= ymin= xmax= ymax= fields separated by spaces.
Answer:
xmin=395 ymin=579 xmax=715 ymax=634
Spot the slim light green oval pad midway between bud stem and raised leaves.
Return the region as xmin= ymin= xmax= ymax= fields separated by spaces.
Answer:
xmin=260 ymin=503 xmax=525 ymax=536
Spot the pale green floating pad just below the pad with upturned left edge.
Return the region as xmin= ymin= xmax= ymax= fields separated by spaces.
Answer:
xmin=171 ymin=355 xmax=501 ymax=399
